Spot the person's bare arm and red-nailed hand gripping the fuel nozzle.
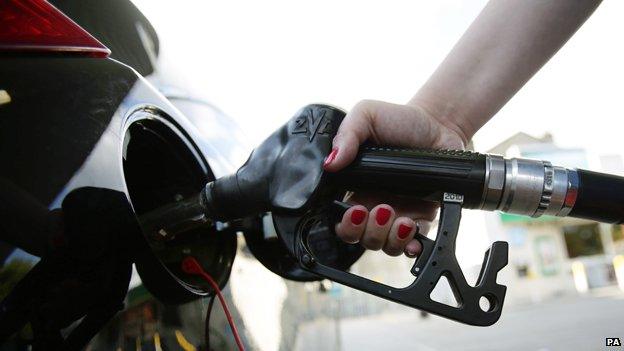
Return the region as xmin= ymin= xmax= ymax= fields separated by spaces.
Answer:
xmin=323 ymin=0 xmax=600 ymax=255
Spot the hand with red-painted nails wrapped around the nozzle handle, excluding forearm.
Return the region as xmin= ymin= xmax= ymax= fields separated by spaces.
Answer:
xmin=323 ymin=100 xmax=465 ymax=257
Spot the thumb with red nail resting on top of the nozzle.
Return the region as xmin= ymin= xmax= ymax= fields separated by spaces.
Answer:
xmin=323 ymin=100 xmax=372 ymax=172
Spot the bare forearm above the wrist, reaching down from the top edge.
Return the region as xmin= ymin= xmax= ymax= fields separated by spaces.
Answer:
xmin=409 ymin=0 xmax=600 ymax=143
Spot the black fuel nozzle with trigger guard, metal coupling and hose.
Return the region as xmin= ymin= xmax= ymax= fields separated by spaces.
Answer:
xmin=136 ymin=104 xmax=624 ymax=326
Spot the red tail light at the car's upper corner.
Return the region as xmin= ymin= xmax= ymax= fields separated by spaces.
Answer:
xmin=0 ymin=0 xmax=110 ymax=57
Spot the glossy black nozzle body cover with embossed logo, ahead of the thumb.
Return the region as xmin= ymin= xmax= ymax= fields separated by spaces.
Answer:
xmin=204 ymin=104 xmax=345 ymax=220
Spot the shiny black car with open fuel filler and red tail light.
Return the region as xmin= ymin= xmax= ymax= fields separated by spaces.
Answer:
xmin=0 ymin=0 xmax=245 ymax=350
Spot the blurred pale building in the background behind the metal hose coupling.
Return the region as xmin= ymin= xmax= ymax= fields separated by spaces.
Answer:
xmin=485 ymin=133 xmax=624 ymax=303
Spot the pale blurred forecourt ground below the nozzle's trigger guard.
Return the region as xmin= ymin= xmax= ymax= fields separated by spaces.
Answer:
xmin=296 ymin=294 xmax=624 ymax=351
